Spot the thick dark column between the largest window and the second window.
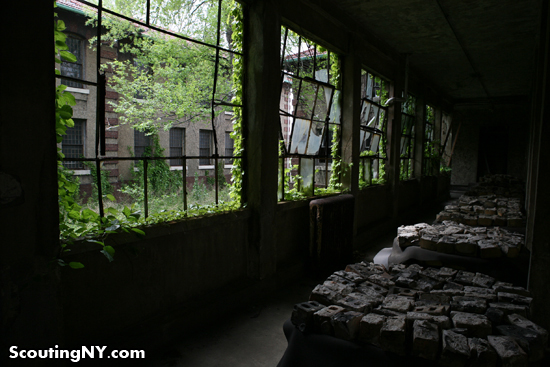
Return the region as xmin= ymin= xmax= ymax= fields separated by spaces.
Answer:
xmin=244 ymin=0 xmax=281 ymax=279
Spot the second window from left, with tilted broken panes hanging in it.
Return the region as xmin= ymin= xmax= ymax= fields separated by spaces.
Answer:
xmin=279 ymin=27 xmax=340 ymax=200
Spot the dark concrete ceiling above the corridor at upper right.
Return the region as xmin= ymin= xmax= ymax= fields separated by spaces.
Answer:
xmin=322 ymin=0 xmax=541 ymax=101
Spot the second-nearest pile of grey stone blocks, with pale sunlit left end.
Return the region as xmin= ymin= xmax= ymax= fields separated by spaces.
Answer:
xmin=397 ymin=221 xmax=524 ymax=258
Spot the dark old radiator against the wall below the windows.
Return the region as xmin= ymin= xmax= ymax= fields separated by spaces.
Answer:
xmin=309 ymin=195 xmax=354 ymax=273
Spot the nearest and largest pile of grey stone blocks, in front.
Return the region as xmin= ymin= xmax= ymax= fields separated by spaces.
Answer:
xmin=291 ymin=262 xmax=548 ymax=367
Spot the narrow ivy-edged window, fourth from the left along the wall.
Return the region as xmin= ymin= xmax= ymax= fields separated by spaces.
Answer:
xmin=399 ymin=94 xmax=416 ymax=180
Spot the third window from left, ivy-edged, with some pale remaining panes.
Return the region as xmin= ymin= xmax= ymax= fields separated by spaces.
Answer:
xmin=359 ymin=71 xmax=388 ymax=186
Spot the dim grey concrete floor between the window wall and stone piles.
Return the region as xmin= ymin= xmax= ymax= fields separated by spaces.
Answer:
xmin=134 ymin=193 xmax=536 ymax=367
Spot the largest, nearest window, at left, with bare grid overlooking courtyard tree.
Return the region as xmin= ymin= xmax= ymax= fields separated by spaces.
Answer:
xmin=55 ymin=0 xmax=244 ymax=230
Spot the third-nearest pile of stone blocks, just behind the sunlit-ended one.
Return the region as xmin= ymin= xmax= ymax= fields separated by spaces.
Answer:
xmin=436 ymin=195 xmax=525 ymax=227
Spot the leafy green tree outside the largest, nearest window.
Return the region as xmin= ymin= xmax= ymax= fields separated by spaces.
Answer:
xmin=89 ymin=0 xmax=239 ymax=133
